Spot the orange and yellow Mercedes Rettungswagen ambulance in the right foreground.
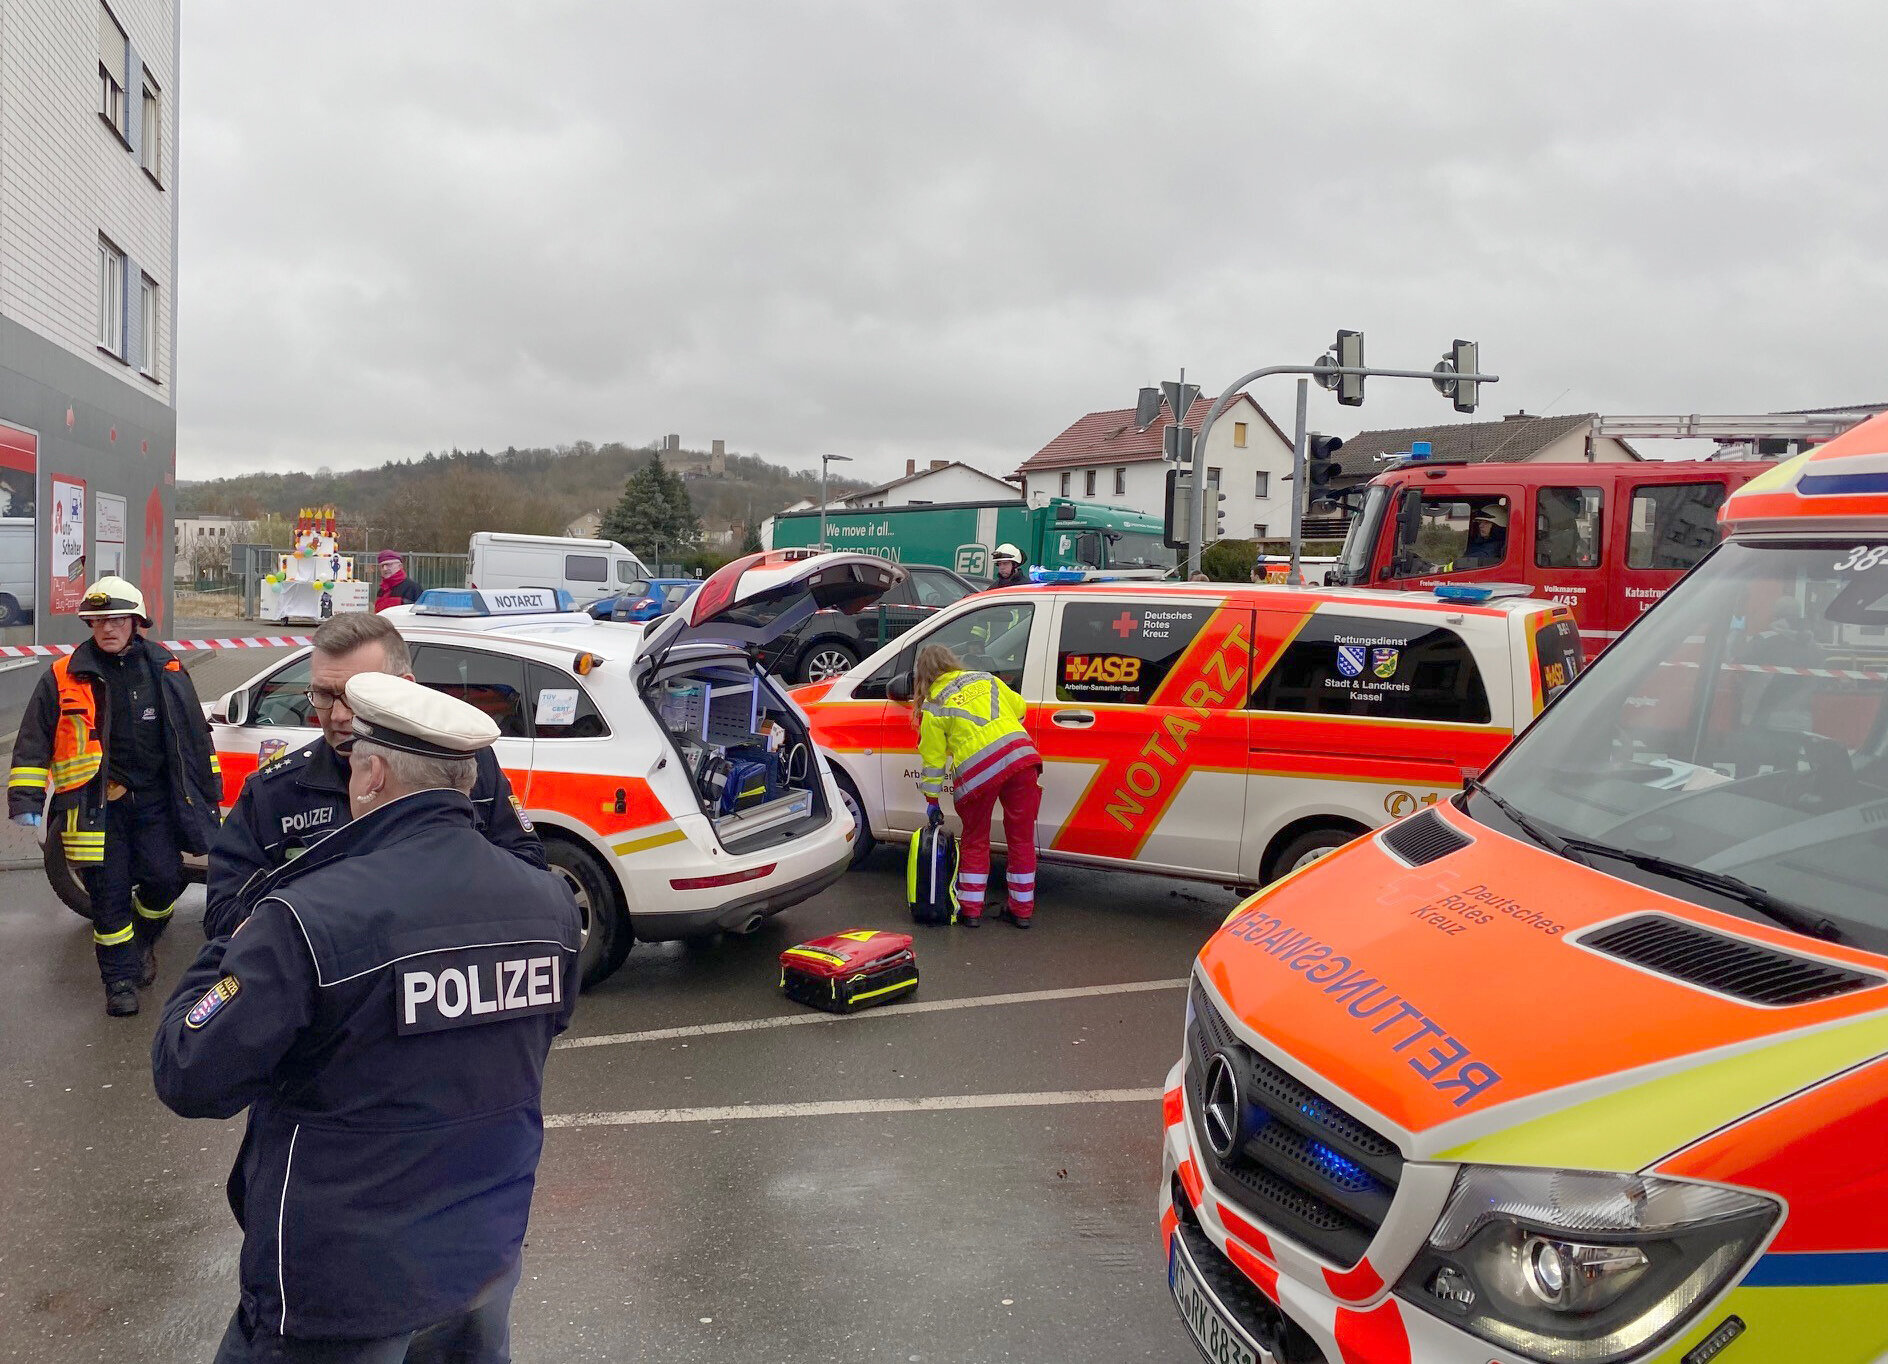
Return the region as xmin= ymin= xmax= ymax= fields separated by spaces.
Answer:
xmin=1159 ymin=418 xmax=1888 ymax=1364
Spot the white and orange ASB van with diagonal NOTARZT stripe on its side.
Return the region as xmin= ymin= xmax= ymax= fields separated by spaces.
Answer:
xmin=793 ymin=582 xmax=1580 ymax=886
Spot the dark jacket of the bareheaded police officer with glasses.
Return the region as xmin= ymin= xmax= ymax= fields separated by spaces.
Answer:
xmin=204 ymin=737 xmax=544 ymax=937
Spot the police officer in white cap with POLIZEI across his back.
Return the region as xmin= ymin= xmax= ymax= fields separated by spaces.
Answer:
xmin=151 ymin=673 xmax=582 ymax=1364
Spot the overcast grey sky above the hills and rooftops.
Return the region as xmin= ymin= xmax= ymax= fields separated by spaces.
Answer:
xmin=177 ymin=0 xmax=1888 ymax=478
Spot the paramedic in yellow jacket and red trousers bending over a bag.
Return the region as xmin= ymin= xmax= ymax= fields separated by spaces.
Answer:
xmin=912 ymin=644 xmax=1042 ymax=928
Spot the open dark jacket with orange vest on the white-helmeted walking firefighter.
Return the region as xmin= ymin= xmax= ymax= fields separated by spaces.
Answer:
xmin=6 ymin=639 xmax=223 ymax=861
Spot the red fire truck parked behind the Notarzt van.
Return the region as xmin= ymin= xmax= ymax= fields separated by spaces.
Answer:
xmin=1325 ymin=461 xmax=1775 ymax=657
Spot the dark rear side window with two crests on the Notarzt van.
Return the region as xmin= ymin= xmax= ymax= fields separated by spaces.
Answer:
xmin=1246 ymin=612 xmax=1495 ymax=725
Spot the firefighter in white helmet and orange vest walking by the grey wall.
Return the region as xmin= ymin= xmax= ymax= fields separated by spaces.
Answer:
xmin=8 ymin=576 xmax=223 ymax=1018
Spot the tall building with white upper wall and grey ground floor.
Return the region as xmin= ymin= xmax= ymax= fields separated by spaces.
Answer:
xmin=0 ymin=0 xmax=177 ymax=642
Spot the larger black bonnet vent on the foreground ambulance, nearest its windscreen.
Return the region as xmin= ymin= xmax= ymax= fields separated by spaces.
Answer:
xmin=1580 ymin=914 xmax=1884 ymax=1005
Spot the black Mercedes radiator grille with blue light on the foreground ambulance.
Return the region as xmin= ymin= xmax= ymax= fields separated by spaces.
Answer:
xmin=1186 ymin=980 xmax=1403 ymax=1266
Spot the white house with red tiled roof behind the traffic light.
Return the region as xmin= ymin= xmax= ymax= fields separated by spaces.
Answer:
xmin=1010 ymin=393 xmax=1291 ymax=540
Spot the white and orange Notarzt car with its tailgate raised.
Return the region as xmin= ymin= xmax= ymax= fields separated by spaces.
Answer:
xmin=211 ymin=552 xmax=902 ymax=986
